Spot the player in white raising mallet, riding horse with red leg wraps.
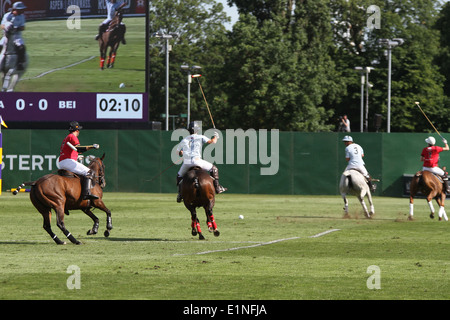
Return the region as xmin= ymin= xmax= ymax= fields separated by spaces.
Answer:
xmin=177 ymin=122 xmax=228 ymax=202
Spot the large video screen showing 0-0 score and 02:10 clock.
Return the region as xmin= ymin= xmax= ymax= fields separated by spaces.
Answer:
xmin=0 ymin=0 xmax=148 ymax=122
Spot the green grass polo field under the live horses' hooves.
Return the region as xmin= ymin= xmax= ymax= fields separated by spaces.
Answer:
xmin=0 ymin=193 xmax=450 ymax=300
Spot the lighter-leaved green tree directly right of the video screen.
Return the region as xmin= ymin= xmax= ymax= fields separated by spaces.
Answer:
xmin=149 ymin=0 xmax=229 ymax=128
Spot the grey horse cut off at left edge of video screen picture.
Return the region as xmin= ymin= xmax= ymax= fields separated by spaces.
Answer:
xmin=0 ymin=34 xmax=28 ymax=92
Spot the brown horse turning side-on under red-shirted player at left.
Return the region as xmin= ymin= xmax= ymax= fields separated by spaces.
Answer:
xmin=14 ymin=154 xmax=113 ymax=244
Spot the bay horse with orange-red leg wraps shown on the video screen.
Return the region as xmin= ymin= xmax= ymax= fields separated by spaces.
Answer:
xmin=98 ymin=9 xmax=126 ymax=70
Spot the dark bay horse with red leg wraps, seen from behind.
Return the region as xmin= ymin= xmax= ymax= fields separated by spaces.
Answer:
xmin=180 ymin=166 xmax=220 ymax=240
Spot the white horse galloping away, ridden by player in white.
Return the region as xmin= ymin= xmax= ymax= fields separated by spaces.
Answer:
xmin=339 ymin=170 xmax=375 ymax=218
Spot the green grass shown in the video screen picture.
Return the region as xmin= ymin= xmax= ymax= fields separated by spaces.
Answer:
xmin=16 ymin=17 xmax=146 ymax=92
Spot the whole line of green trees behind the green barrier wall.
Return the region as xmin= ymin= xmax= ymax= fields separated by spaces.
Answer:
xmin=149 ymin=0 xmax=450 ymax=132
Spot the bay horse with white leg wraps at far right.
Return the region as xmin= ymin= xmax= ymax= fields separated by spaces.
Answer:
xmin=408 ymin=171 xmax=448 ymax=221
